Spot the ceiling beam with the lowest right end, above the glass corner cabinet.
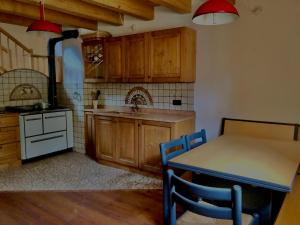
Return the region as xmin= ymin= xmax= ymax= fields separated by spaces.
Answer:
xmin=0 ymin=0 xmax=98 ymax=30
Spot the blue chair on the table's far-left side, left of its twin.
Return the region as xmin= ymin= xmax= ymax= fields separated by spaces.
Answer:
xmin=160 ymin=137 xmax=187 ymax=225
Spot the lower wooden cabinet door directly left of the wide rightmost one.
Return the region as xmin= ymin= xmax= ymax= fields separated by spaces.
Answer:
xmin=116 ymin=118 xmax=138 ymax=167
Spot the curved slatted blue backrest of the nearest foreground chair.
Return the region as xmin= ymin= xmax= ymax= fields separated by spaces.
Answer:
xmin=167 ymin=170 xmax=242 ymax=225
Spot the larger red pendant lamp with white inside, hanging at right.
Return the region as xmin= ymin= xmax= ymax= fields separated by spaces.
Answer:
xmin=193 ymin=0 xmax=239 ymax=25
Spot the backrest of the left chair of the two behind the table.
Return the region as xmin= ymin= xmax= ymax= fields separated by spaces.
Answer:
xmin=160 ymin=137 xmax=187 ymax=167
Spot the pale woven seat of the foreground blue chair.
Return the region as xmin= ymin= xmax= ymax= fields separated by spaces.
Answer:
xmin=176 ymin=211 xmax=253 ymax=225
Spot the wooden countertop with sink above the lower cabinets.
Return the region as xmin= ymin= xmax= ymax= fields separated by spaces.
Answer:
xmin=85 ymin=107 xmax=195 ymax=123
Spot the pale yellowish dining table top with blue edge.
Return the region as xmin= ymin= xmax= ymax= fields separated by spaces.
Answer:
xmin=169 ymin=135 xmax=300 ymax=192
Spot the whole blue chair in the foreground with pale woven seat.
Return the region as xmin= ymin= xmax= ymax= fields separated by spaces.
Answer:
xmin=167 ymin=170 xmax=259 ymax=225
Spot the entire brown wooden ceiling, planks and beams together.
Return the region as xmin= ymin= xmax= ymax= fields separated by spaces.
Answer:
xmin=0 ymin=0 xmax=192 ymax=30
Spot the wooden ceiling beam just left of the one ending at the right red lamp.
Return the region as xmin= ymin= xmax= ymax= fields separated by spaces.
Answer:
xmin=81 ymin=0 xmax=154 ymax=20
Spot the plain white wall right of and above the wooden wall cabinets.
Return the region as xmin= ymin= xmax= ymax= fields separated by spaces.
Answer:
xmin=95 ymin=0 xmax=300 ymax=138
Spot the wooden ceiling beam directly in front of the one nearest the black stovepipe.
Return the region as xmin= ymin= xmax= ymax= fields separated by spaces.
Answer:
xmin=18 ymin=0 xmax=124 ymax=25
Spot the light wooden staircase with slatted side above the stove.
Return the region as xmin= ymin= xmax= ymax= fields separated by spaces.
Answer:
xmin=0 ymin=27 xmax=48 ymax=76
